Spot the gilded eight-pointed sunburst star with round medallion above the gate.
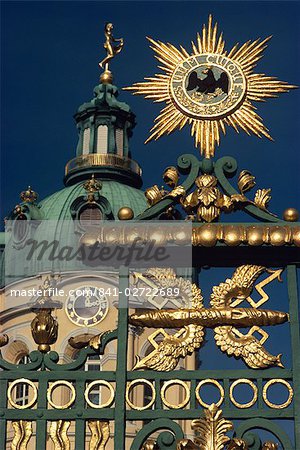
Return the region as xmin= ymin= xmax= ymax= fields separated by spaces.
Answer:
xmin=125 ymin=16 xmax=296 ymax=158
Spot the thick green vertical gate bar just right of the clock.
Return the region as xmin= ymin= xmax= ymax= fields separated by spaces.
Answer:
xmin=114 ymin=267 xmax=129 ymax=450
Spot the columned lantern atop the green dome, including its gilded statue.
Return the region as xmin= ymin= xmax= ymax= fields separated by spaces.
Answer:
xmin=64 ymin=23 xmax=142 ymax=188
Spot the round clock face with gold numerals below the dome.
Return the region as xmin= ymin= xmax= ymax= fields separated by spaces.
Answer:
xmin=65 ymin=285 xmax=108 ymax=327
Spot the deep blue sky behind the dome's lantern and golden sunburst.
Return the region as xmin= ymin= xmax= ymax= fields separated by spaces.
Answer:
xmin=1 ymin=1 xmax=300 ymax=218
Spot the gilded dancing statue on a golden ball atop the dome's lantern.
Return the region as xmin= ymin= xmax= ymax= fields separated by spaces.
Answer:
xmin=99 ymin=22 xmax=124 ymax=84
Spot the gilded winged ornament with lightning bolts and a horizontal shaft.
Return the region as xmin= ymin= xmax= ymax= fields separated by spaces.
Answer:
xmin=129 ymin=264 xmax=289 ymax=371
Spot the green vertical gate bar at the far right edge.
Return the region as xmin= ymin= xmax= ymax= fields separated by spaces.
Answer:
xmin=287 ymin=265 xmax=300 ymax=448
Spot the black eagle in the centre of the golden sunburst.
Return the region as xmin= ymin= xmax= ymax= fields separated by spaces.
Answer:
xmin=186 ymin=69 xmax=229 ymax=94
